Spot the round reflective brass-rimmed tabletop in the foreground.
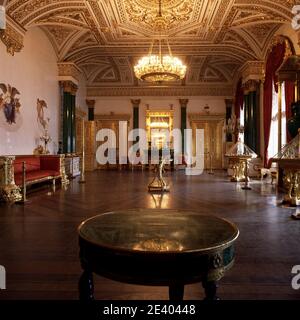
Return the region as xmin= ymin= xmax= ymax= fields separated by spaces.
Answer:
xmin=79 ymin=209 xmax=239 ymax=253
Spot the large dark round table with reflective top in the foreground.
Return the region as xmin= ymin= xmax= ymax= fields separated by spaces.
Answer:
xmin=78 ymin=209 xmax=239 ymax=300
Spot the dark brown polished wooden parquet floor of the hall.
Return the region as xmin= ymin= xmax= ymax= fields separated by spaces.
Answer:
xmin=0 ymin=171 xmax=300 ymax=300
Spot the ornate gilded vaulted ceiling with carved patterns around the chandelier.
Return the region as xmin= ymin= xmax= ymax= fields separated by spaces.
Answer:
xmin=2 ymin=0 xmax=295 ymax=95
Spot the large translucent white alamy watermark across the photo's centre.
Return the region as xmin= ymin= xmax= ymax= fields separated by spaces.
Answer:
xmin=96 ymin=121 xmax=205 ymax=175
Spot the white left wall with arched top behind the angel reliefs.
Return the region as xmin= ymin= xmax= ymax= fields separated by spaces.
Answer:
xmin=0 ymin=28 xmax=60 ymax=155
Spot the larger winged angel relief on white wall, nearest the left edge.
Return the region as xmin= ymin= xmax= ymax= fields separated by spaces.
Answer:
xmin=0 ymin=83 xmax=21 ymax=125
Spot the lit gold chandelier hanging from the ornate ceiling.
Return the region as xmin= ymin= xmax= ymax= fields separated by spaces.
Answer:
xmin=134 ymin=0 xmax=186 ymax=83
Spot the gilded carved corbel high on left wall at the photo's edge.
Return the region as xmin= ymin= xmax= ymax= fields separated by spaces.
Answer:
xmin=0 ymin=16 xmax=26 ymax=56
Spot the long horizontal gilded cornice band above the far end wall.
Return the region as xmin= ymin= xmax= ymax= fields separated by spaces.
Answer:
xmin=87 ymin=85 xmax=233 ymax=97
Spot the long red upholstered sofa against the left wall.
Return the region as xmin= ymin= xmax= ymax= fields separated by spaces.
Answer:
xmin=13 ymin=155 xmax=62 ymax=186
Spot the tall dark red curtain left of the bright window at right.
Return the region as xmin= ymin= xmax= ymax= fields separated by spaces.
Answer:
xmin=264 ymin=42 xmax=286 ymax=166
